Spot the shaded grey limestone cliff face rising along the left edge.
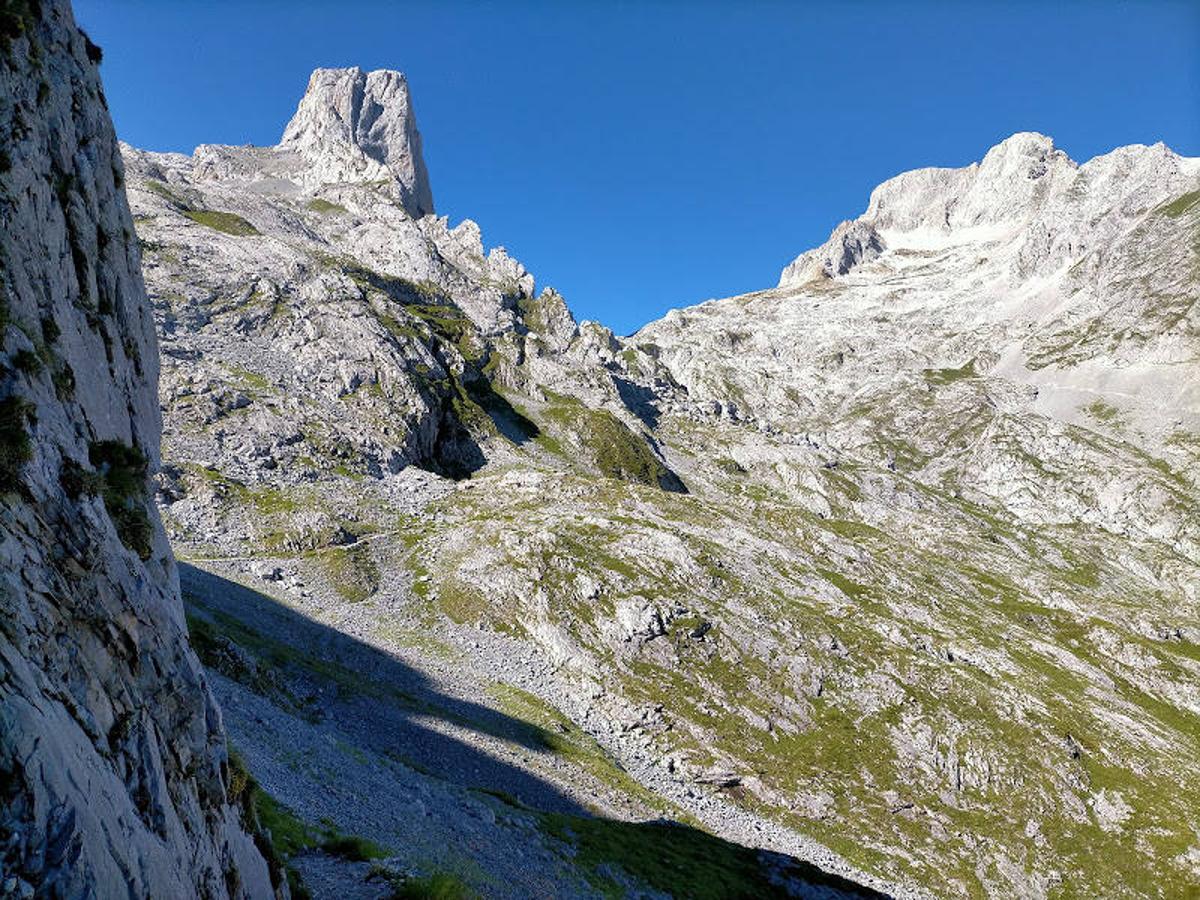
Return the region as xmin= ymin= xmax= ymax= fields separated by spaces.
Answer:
xmin=0 ymin=0 xmax=274 ymax=898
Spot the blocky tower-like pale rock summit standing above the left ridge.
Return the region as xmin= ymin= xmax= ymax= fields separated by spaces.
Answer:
xmin=278 ymin=66 xmax=433 ymax=218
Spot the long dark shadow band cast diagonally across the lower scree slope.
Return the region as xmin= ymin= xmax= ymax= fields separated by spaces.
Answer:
xmin=179 ymin=563 xmax=884 ymax=900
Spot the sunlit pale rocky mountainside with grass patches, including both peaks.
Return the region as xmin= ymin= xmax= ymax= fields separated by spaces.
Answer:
xmin=125 ymin=70 xmax=1200 ymax=896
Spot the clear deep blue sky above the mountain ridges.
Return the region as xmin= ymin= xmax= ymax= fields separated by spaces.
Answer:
xmin=76 ymin=0 xmax=1200 ymax=332
